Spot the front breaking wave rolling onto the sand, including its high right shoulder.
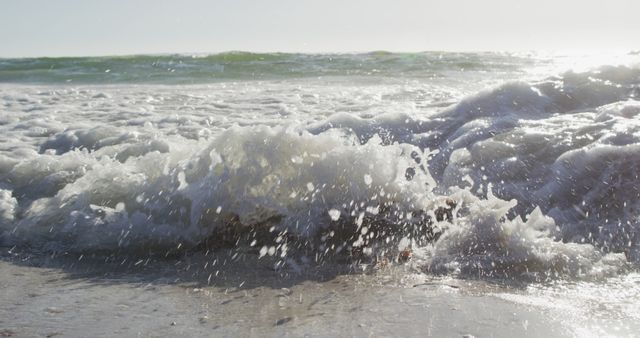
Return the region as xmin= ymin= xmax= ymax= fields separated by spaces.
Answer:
xmin=0 ymin=60 xmax=640 ymax=278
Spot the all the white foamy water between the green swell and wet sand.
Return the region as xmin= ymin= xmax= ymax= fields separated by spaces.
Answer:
xmin=0 ymin=58 xmax=640 ymax=277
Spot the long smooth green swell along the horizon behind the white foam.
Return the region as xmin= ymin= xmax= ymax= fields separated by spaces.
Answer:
xmin=0 ymin=52 xmax=527 ymax=84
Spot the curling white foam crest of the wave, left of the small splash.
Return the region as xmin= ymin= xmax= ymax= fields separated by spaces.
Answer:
xmin=1 ymin=126 xmax=433 ymax=249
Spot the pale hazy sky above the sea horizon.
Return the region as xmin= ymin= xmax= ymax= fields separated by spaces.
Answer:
xmin=0 ymin=0 xmax=640 ymax=57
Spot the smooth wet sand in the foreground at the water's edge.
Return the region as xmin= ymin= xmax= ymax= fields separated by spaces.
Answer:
xmin=0 ymin=252 xmax=640 ymax=337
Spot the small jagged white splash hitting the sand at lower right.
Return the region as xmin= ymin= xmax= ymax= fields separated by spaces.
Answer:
xmin=426 ymin=191 xmax=627 ymax=280
